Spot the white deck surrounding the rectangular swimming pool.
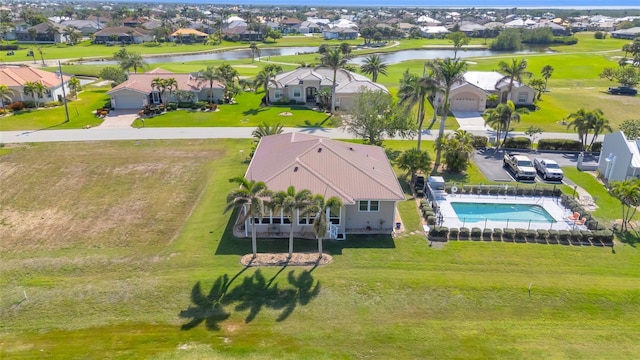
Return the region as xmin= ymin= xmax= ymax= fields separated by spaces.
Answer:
xmin=437 ymin=194 xmax=587 ymax=230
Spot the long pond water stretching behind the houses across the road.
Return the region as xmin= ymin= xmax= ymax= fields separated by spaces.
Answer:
xmin=83 ymin=46 xmax=549 ymax=65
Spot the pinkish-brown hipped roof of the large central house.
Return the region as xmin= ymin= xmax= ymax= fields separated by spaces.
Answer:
xmin=245 ymin=133 xmax=404 ymax=204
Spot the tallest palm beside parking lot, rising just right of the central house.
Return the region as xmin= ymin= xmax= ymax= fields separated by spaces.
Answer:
xmin=427 ymin=58 xmax=467 ymax=172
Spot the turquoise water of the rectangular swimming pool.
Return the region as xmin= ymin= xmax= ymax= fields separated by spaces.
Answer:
xmin=451 ymin=202 xmax=556 ymax=223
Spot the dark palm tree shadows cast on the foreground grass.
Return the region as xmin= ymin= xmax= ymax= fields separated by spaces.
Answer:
xmin=179 ymin=266 xmax=320 ymax=330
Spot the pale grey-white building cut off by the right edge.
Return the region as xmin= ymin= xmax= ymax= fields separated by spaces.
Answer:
xmin=598 ymin=131 xmax=640 ymax=181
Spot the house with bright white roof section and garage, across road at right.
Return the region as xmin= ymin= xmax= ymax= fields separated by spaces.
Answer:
xmin=435 ymin=71 xmax=536 ymax=111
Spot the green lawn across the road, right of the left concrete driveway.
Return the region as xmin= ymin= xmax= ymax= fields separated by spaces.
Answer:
xmin=133 ymin=92 xmax=335 ymax=127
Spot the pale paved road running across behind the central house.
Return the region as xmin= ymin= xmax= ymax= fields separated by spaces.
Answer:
xmin=0 ymin=127 xmax=592 ymax=144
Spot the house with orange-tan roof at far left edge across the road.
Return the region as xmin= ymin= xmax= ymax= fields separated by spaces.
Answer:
xmin=0 ymin=65 xmax=70 ymax=103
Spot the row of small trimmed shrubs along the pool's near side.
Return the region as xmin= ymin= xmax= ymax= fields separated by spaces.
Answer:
xmin=429 ymin=226 xmax=613 ymax=245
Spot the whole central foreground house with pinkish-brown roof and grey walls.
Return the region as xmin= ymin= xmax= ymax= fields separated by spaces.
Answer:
xmin=244 ymin=132 xmax=405 ymax=239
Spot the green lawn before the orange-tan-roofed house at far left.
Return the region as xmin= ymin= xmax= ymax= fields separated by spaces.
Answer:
xmin=0 ymin=87 xmax=109 ymax=131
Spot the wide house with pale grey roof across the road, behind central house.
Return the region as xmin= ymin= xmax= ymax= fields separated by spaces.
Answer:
xmin=269 ymin=67 xmax=388 ymax=110
